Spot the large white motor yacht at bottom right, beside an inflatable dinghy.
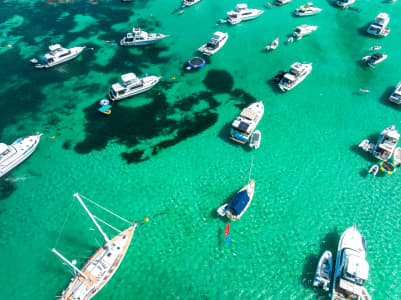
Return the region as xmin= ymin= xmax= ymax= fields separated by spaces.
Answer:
xmin=331 ymin=224 xmax=369 ymax=300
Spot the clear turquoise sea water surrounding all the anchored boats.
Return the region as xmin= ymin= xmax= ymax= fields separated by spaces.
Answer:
xmin=0 ymin=0 xmax=401 ymax=299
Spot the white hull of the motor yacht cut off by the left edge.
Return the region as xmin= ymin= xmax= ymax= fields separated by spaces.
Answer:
xmin=0 ymin=134 xmax=42 ymax=178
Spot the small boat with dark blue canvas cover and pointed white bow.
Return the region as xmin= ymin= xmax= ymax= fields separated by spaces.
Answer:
xmin=226 ymin=180 xmax=255 ymax=221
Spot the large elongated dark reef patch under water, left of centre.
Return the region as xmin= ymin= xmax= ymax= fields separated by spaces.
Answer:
xmin=74 ymin=89 xmax=219 ymax=163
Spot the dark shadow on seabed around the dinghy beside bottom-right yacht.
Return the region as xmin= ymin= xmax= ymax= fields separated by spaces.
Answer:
xmin=300 ymin=227 xmax=340 ymax=299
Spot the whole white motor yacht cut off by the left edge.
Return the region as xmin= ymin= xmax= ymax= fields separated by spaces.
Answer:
xmin=0 ymin=134 xmax=42 ymax=178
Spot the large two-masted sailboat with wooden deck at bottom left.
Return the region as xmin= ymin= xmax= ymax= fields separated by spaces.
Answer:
xmin=52 ymin=193 xmax=138 ymax=300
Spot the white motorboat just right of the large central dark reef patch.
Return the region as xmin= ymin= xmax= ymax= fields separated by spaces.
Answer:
xmin=230 ymin=101 xmax=265 ymax=144
